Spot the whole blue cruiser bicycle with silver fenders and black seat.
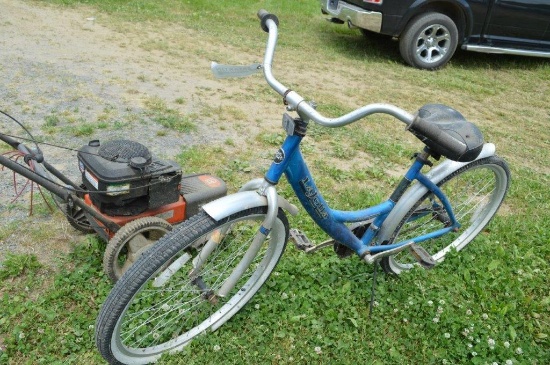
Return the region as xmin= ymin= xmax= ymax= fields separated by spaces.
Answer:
xmin=96 ymin=10 xmax=510 ymax=364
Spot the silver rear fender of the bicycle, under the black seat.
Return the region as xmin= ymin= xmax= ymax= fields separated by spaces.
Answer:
xmin=378 ymin=143 xmax=496 ymax=243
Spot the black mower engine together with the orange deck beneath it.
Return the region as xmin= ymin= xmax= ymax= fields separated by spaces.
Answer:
xmin=77 ymin=140 xmax=227 ymax=241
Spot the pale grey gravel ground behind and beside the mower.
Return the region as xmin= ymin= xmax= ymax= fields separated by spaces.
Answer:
xmin=0 ymin=0 xmax=260 ymax=261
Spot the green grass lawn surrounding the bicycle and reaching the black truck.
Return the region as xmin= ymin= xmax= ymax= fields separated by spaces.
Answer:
xmin=0 ymin=0 xmax=550 ymax=365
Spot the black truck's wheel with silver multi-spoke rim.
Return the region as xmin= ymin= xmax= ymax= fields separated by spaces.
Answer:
xmin=399 ymin=13 xmax=458 ymax=70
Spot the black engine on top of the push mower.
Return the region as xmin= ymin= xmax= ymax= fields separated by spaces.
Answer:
xmin=77 ymin=140 xmax=182 ymax=216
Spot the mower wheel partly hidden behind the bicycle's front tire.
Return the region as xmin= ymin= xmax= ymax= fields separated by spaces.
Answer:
xmin=103 ymin=217 xmax=172 ymax=283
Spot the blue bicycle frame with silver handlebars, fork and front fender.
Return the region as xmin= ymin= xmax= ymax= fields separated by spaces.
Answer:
xmin=203 ymin=10 xmax=500 ymax=296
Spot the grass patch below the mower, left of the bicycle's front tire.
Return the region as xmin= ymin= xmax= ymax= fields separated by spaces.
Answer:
xmin=0 ymin=237 xmax=109 ymax=364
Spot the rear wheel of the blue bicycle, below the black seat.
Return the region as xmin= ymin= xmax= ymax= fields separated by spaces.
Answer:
xmin=380 ymin=156 xmax=510 ymax=274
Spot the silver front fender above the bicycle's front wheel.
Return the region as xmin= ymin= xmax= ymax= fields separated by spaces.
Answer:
xmin=202 ymin=191 xmax=298 ymax=220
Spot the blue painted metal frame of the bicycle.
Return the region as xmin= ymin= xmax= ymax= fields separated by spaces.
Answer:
xmin=265 ymin=121 xmax=460 ymax=257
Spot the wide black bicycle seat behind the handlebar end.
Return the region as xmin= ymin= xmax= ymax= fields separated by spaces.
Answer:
xmin=407 ymin=104 xmax=483 ymax=162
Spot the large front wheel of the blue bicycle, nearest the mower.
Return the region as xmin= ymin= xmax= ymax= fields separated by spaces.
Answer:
xmin=95 ymin=207 xmax=288 ymax=364
